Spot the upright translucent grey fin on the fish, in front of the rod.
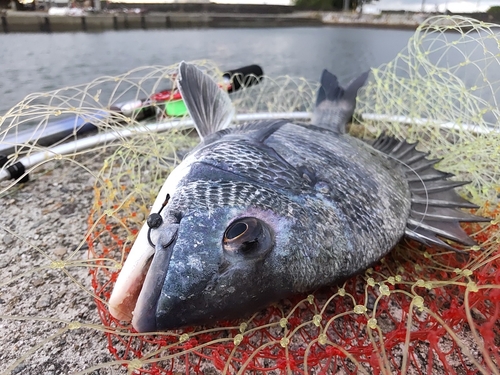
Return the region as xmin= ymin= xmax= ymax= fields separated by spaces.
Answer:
xmin=177 ymin=61 xmax=234 ymax=140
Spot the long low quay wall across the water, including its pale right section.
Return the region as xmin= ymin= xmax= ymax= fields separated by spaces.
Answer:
xmin=0 ymin=6 xmax=492 ymax=33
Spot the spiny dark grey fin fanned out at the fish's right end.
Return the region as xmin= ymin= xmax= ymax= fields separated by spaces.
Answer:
xmin=372 ymin=135 xmax=490 ymax=251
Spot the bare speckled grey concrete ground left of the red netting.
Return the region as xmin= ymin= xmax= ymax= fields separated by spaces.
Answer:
xmin=0 ymin=156 xmax=125 ymax=375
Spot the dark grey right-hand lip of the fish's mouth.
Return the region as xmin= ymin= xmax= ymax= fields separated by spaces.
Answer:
xmin=132 ymin=226 xmax=177 ymax=333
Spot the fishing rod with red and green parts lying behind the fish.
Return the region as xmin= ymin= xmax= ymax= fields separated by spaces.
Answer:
xmin=0 ymin=64 xmax=264 ymax=162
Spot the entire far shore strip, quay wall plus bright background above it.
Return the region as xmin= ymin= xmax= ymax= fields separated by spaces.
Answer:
xmin=0 ymin=0 xmax=492 ymax=33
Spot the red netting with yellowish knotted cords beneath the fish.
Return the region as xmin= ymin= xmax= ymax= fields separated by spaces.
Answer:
xmin=88 ymin=156 xmax=500 ymax=374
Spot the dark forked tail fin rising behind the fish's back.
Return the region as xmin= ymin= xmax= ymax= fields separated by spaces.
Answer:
xmin=312 ymin=69 xmax=369 ymax=134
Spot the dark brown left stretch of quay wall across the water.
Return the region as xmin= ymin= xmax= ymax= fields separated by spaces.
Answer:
xmin=0 ymin=4 xmax=323 ymax=33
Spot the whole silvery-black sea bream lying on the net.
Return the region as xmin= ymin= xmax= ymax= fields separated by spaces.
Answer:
xmin=109 ymin=63 xmax=483 ymax=332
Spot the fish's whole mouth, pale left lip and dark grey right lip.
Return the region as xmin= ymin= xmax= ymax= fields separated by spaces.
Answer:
xmin=109 ymin=226 xmax=177 ymax=332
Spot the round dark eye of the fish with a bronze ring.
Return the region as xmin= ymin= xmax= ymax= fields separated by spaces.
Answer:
xmin=222 ymin=217 xmax=273 ymax=257
